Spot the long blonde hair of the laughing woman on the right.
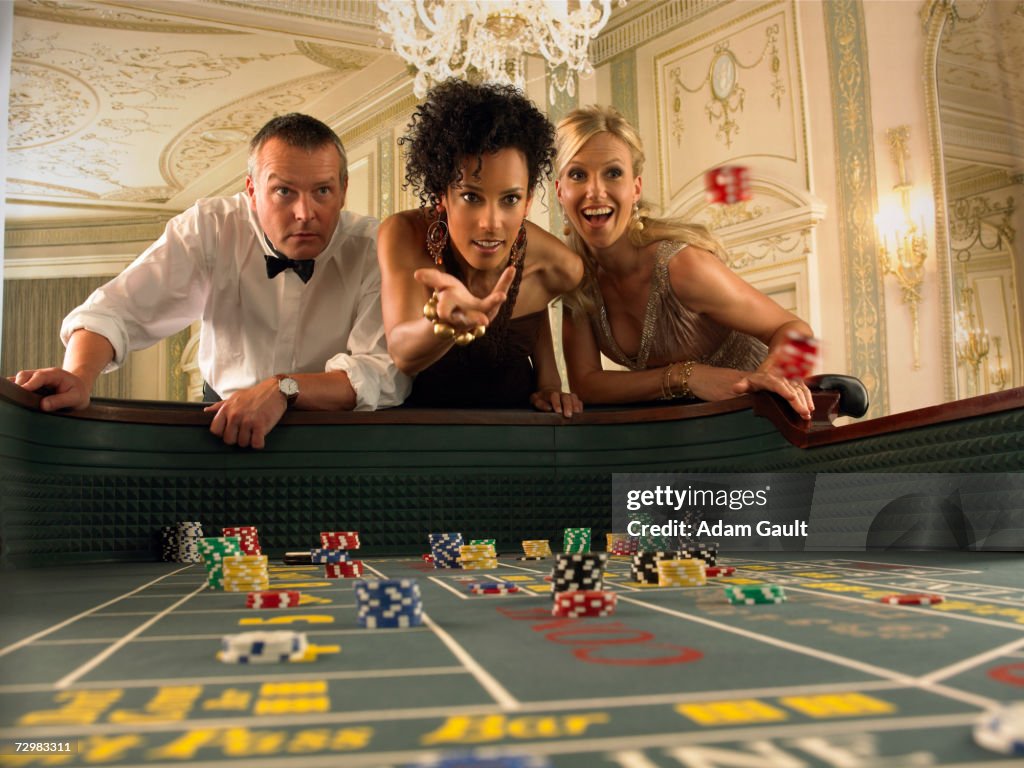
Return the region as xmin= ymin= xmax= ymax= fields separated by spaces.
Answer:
xmin=555 ymin=104 xmax=726 ymax=314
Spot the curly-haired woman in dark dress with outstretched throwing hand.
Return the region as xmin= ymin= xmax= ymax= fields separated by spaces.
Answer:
xmin=377 ymin=80 xmax=583 ymax=416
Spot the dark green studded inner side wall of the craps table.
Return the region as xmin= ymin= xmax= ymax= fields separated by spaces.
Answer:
xmin=0 ymin=381 xmax=1024 ymax=565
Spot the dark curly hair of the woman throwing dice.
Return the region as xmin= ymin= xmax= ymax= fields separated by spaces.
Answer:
xmin=398 ymin=80 xmax=555 ymax=207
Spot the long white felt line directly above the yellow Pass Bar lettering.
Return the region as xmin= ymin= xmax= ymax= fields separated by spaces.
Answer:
xmin=0 ymin=679 xmax=913 ymax=737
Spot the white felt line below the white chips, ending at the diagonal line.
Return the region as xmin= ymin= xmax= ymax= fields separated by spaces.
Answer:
xmin=0 ymin=667 xmax=469 ymax=696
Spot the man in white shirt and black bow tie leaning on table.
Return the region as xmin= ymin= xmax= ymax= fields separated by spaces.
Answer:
xmin=14 ymin=114 xmax=411 ymax=449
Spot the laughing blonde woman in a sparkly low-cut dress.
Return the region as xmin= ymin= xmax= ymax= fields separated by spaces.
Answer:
xmin=555 ymin=106 xmax=814 ymax=419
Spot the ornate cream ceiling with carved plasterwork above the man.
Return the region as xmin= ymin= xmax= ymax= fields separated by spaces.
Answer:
xmin=7 ymin=0 xmax=385 ymax=218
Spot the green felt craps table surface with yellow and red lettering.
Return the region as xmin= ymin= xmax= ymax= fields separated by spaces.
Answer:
xmin=0 ymin=552 xmax=1024 ymax=768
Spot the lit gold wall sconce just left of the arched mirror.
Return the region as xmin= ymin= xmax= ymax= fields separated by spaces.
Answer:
xmin=876 ymin=125 xmax=928 ymax=370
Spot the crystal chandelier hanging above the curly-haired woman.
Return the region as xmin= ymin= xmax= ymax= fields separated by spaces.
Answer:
xmin=378 ymin=0 xmax=626 ymax=103
